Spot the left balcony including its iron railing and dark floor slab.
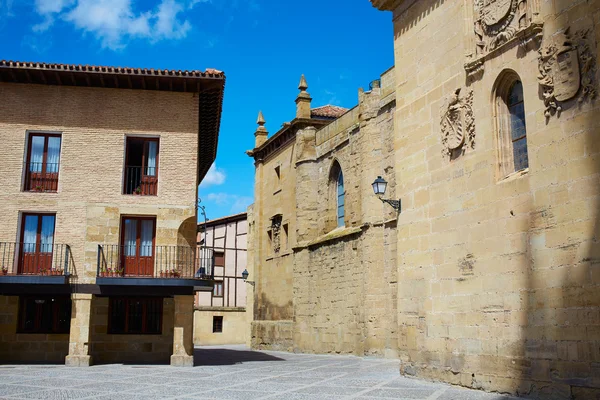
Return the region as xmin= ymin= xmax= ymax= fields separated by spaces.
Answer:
xmin=0 ymin=242 xmax=71 ymax=285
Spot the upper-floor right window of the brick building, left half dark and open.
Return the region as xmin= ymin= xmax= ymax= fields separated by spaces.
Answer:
xmin=123 ymin=137 xmax=159 ymax=196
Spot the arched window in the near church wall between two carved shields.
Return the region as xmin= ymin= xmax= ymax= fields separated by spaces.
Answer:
xmin=496 ymin=71 xmax=529 ymax=178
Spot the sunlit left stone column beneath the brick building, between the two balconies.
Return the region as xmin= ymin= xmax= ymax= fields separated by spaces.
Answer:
xmin=65 ymin=293 xmax=93 ymax=367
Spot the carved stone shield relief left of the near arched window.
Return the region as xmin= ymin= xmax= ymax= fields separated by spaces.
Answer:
xmin=440 ymin=89 xmax=475 ymax=158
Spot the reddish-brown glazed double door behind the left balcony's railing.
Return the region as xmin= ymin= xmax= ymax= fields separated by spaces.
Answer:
xmin=18 ymin=214 xmax=56 ymax=275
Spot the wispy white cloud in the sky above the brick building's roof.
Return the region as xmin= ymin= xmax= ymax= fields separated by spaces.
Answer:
xmin=33 ymin=0 xmax=199 ymax=50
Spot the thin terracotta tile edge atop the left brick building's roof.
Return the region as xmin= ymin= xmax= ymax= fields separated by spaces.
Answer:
xmin=0 ymin=60 xmax=224 ymax=77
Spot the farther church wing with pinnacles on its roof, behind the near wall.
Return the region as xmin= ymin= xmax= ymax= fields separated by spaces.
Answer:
xmin=249 ymin=69 xmax=397 ymax=357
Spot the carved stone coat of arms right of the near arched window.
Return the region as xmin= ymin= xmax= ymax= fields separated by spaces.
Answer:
xmin=538 ymin=28 xmax=597 ymax=118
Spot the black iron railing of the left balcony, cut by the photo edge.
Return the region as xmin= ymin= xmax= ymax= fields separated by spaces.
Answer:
xmin=0 ymin=242 xmax=71 ymax=276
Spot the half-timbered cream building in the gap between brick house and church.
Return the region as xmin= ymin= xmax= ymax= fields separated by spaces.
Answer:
xmin=194 ymin=213 xmax=251 ymax=345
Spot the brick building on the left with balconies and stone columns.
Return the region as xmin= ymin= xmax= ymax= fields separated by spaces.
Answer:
xmin=0 ymin=61 xmax=225 ymax=366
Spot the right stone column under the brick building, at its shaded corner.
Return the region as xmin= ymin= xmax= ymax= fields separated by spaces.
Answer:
xmin=171 ymin=295 xmax=194 ymax=367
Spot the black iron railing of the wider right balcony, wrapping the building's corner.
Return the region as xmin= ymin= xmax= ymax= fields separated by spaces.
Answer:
xmin=97 ymin=244 xmax=214 ymax=279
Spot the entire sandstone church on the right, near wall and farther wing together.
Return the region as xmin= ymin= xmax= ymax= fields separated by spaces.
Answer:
xmin=249 ymin=0 xmax=600 ymax=399
